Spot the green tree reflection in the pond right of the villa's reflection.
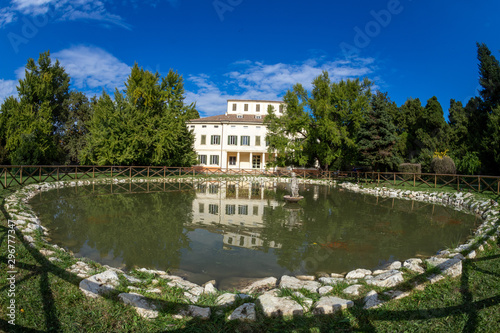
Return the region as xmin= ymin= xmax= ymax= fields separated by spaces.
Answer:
xmin=261 ymin=186 xmax=469 ymax=273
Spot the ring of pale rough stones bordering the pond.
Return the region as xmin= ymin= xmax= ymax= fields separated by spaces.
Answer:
xmin=4 ymin=176 xmax=500 ymax=321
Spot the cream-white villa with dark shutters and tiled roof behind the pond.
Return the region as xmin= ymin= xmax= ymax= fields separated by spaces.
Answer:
xmin=187 ymin=100 xmax=285 ymax=170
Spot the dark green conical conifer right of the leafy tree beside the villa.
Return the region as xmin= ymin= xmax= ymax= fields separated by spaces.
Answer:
xmin=358 ymin=92 xmax=402 ymax=170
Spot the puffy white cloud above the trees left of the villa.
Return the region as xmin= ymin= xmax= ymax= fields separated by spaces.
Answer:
xmin=52 ymin=45 xmax=131 ymax=93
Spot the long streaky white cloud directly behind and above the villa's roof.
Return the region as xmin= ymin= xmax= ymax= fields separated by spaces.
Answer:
xmin=186 ymin=58 xmax=376 ymax=116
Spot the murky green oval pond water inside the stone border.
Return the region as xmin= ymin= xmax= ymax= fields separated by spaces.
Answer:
xmin=30 ymin=182 xmax=480 ymax=289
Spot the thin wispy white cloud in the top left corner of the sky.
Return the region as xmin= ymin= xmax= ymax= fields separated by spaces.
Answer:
xmin=0 ymin=0 xmax=130 ymax=29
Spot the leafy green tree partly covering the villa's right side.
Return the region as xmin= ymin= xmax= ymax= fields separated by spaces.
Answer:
xmin=265 ymin=72 xmax=371 ymax=170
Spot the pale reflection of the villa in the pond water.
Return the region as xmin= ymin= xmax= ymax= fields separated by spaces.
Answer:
xmin=193 ymin=182 xmax=281 ymax=249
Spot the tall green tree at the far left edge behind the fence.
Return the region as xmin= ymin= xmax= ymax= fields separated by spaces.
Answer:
xmin=1 ymin=51 xmax=70 ymax=164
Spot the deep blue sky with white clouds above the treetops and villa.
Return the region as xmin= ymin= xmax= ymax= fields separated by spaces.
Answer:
xmin=0 ymin=0 xmax=500 ymax=116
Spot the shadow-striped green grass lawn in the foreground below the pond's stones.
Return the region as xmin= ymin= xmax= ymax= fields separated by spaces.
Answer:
xmin=0 ymin=182 xmax=500 ymax=332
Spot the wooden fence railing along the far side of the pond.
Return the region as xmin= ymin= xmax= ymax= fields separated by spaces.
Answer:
xmin=0 ymin=165 xmax=500 ymax=195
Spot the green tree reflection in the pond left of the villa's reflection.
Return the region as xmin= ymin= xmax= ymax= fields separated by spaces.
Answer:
xmin=34 ymin=184 xmax=195 ymax=268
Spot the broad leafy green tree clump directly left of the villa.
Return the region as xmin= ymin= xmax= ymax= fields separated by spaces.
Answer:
xmin=80 ymin=64 xmax=197 ymax=166
